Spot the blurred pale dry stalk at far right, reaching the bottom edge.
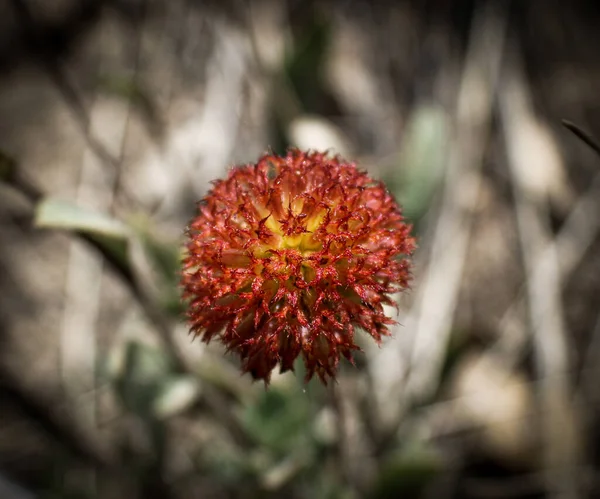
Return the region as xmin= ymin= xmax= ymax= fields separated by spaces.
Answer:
xmin=500 ymin=58 xmax=580 ymax=499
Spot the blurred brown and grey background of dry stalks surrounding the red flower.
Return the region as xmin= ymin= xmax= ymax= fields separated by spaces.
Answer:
xmin=0 ymin=0 xmax=600 ymax=499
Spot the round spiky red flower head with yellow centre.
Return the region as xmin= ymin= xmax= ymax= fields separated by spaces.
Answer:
xmin=181 ymin=149 xmax=415 ymax=384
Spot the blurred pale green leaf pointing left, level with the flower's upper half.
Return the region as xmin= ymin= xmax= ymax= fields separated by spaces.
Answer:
xmin=34 ymin=198 xmax=129 ymax=267
